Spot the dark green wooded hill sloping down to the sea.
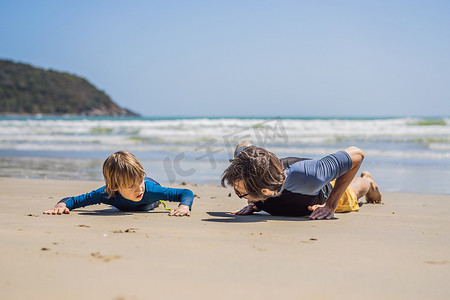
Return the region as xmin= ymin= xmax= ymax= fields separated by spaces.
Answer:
xmin=0 ymin=60 xmax=137 ymax=116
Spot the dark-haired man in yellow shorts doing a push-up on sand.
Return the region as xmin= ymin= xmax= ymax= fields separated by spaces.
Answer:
xmin=222 ymin=142 xmax=382 ymax=219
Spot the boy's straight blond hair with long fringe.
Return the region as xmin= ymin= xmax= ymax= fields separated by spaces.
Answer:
xmin=103 ymin=151 xmax=145 ymax=197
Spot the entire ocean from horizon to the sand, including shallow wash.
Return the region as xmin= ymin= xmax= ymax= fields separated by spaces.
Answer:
xmin=0 ymin=116 xmax=450 ymax=194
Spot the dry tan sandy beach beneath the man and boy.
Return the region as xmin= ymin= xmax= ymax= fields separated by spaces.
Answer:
xmin=0 ymin=178 xmax=450 ymax=300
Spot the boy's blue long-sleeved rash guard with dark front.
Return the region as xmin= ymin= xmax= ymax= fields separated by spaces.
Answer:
xmin=59 ymin=178 xmax=194 ymax=211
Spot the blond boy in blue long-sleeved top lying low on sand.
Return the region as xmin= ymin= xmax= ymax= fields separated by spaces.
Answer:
xmin=44 ymin=151 xmax=194 ymax=216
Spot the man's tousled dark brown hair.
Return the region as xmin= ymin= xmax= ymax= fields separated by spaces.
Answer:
xmin=221 ymin=146 xmax=286 ymax=198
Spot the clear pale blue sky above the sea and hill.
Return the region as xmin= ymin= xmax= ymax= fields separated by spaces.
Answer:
xmin=0 ymin=0 xmax=450 ymax=117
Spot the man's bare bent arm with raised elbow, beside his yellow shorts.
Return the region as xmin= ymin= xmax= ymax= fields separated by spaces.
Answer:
xmin=309 ymin=147 xmax=364 ymax=220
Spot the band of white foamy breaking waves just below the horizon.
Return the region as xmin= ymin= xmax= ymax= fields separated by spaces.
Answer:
xmin=0 ymin=118 xmax=450 ymax=159
